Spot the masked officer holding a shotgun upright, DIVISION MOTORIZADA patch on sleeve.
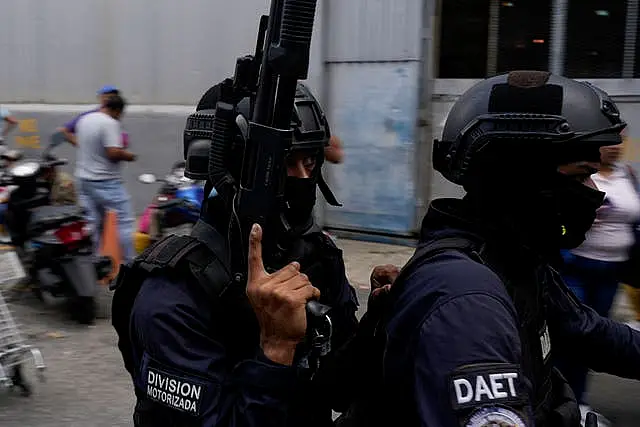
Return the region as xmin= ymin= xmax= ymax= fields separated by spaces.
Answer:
xmin=113 ymin=84 xmax=357 ymax=427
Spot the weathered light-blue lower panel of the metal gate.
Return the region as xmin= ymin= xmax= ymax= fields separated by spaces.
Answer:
xmin=326 ymin=63 xmax=418 ymax=234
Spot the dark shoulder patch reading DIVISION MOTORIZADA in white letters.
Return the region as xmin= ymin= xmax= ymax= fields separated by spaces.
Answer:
xmin=140 ymin=357 xmax=213 ymax=416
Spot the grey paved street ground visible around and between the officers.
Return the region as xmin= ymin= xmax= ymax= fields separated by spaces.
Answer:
xmin=0 ymin=239 xmax=640 ymax=427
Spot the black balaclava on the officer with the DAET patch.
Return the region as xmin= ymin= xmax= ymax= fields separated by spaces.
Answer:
xmin=465 ymin=159 xmax=604 ymax=256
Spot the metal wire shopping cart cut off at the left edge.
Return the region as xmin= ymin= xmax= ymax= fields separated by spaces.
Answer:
xmin=0 ymin=246 xmax=45 ymax=396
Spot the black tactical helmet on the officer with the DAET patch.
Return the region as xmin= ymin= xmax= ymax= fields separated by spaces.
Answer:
xmin=433 ymin=71 xmax=626 ymax=188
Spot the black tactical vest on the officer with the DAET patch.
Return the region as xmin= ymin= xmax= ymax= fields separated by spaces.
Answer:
xmin=336 ymin=236 xmax=580 ymax=427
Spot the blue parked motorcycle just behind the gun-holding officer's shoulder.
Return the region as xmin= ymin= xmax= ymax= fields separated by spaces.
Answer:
xmin=134 ymin=162 xmax=204 ymax=253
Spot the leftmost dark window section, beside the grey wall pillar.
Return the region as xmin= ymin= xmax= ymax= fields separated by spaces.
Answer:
xmin=437 ymin=0 xmax=489 ymax=79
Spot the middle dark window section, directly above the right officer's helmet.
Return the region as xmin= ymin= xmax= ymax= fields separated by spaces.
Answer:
xmin=496 ymin=0 xmax=551 ymax=73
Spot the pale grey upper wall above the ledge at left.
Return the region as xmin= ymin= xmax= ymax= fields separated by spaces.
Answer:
xmin=0 ymin=0 xmax=328 ymax=105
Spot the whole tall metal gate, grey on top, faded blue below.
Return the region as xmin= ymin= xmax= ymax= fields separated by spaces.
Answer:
xmin=323 ymin=0 xmax=422 ymax=235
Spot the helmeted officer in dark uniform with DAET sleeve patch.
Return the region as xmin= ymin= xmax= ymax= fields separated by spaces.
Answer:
xmin=352 ymin=71 xmax=640 ymax=427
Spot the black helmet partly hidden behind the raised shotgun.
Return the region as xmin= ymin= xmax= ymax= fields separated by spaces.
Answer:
xmin=183 ymin=82 xmax=331 ymax=180
